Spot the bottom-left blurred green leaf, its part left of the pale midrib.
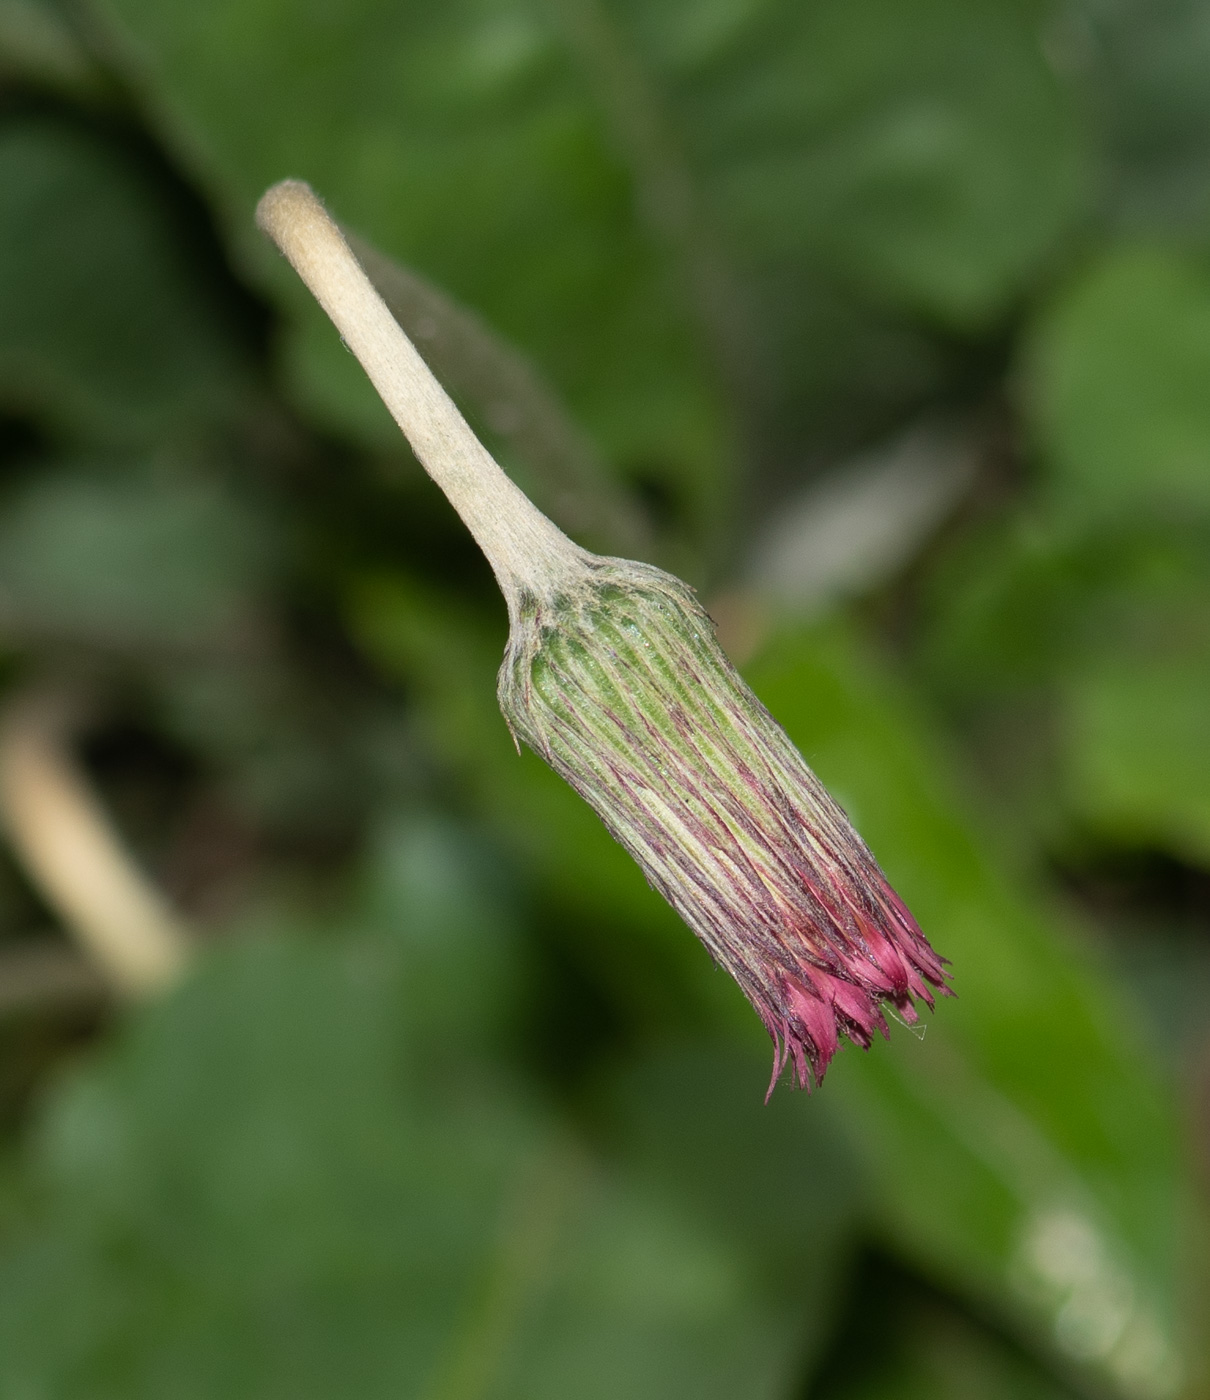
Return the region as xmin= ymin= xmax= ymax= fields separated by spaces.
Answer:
xmin=0 ymin=941 xmax=534 ymax=1397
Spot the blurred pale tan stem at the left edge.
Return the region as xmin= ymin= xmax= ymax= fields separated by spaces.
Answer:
xmin=0 ymin=692 xmax=189 ymax=997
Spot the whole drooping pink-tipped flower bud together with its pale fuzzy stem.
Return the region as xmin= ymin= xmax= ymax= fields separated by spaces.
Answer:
xmin=258 ymin=181 xmax=947 ymax=1092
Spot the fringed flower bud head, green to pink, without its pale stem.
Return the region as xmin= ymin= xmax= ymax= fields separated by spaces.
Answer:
xmin=499 ymin=557 xmax=945 ymax=1092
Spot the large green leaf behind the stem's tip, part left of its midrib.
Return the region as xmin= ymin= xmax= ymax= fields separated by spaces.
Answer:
xmin=96 ymin=0 xmax=723 ymax=529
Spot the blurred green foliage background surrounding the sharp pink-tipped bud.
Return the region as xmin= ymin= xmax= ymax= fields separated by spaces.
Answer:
xmin=0 ymin=0 xmax=1210 ymax=1400
